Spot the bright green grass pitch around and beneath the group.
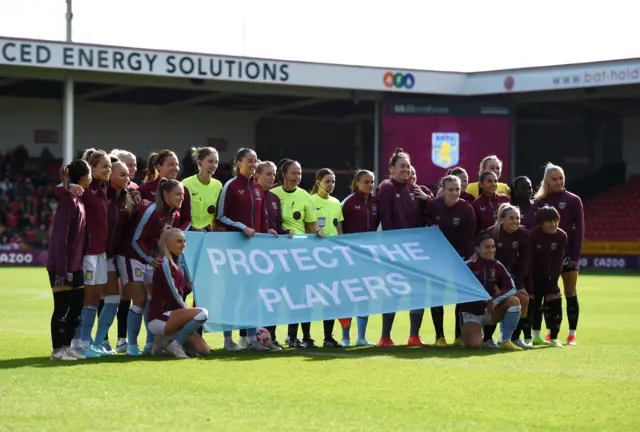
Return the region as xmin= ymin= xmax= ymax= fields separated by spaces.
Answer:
xmin=0 ymin=269 xmax=640 ymax=431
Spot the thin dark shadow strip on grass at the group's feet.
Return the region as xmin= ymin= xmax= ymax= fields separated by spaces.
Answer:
xmin=0 ymin=346 xmax=536 ymax=370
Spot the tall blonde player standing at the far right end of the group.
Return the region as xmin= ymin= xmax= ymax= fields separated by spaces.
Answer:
xmin=534 ymin=162 xmax=584 ymax=345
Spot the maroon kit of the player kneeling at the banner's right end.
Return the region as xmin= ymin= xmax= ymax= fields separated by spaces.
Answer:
xmin=460 ymin=256 xmax=516 ymax=315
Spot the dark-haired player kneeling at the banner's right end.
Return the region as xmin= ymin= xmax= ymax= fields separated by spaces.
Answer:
xmin=460 ymin=233 xmax=522 ymax=351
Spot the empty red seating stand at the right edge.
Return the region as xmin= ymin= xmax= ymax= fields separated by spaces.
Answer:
xmin=585 ymin=176 xmax=640 ymax=242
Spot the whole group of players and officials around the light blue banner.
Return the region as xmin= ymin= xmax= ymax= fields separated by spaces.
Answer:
xmin=47 ymin=147 xmax=584 ymax=361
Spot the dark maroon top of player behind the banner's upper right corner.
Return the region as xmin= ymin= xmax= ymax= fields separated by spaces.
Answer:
xmin=426 ymin=197 xmax=476 ymax=258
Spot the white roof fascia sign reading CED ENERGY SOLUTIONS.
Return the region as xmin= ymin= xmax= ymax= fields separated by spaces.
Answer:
xmin=0 ymin=38 xmax=466 ymax=94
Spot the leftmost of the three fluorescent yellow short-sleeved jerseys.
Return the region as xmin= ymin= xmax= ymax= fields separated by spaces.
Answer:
xmin=182 ymin=175 xmax=222 ymax=229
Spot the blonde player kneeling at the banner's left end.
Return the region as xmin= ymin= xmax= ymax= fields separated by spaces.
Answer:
xmin=149 ymin=228 xmax=211 ymax=358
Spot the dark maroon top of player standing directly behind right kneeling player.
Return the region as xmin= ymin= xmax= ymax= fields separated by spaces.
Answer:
xmin=486 ymin=226 xmax=531 ymax=290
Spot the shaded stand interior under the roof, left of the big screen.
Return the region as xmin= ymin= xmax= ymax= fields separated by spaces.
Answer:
xmin=0 ymin=66 xmax=382 ymax=198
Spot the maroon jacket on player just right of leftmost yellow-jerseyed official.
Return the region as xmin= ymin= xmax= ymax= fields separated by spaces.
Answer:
xmin=217 ymin=174 xmax=269 ymax=233
